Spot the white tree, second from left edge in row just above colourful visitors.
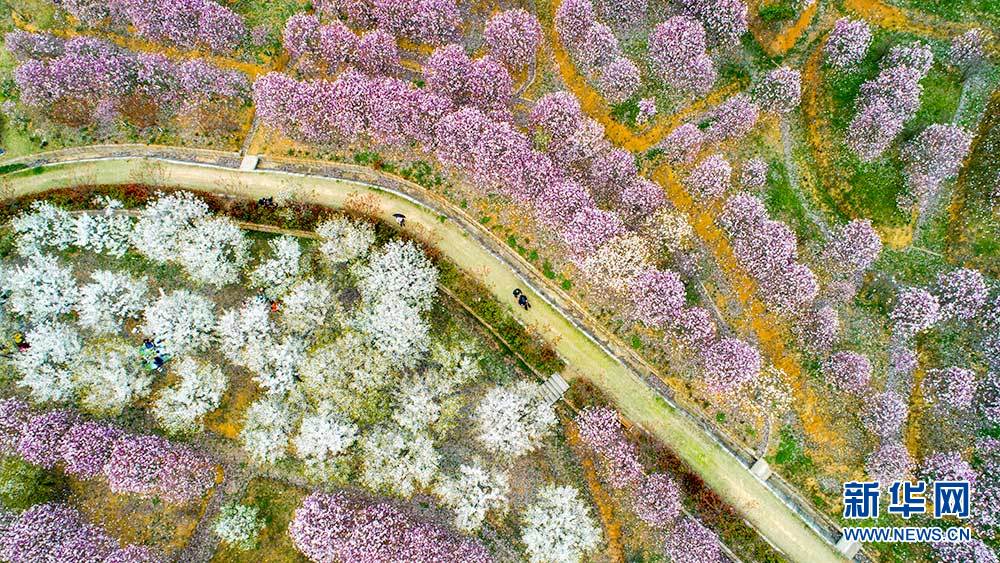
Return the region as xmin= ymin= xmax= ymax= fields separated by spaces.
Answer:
xmin=76 ymin=270 xmax=147 ymax=334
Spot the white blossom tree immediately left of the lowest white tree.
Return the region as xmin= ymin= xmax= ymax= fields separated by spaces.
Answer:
xmin=435 ymin=464 xmax=510 ymax=533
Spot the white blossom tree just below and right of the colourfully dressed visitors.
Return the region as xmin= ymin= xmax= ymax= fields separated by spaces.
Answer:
xmin=153 ymin=356 xmax=229 ymax=434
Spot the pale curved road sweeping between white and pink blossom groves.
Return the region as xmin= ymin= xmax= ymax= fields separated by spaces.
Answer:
xmin=0 ymin=145 xmax=844 ymax=563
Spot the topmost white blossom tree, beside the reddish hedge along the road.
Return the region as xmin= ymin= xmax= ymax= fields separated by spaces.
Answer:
xmin=132 ymin=192 xmax=209 ymax=263
